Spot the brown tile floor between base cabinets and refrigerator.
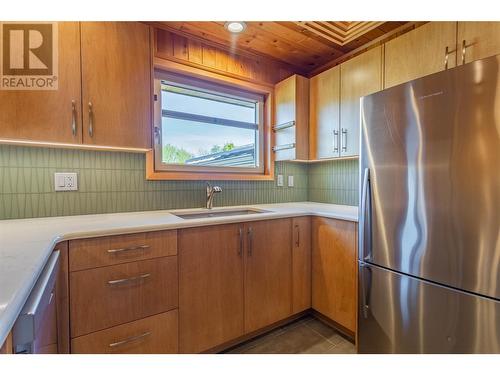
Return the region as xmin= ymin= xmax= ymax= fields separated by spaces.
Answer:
xmin=224 ymin=316 xmax=356 ymax=354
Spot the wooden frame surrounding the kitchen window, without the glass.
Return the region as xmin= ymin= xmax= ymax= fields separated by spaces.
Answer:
xmin=146 ymin=69 xmax=274 ymax=180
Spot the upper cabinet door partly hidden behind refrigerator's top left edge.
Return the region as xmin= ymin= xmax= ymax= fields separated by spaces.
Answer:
xmin=340 ymin=46 xmax=382 ymax=157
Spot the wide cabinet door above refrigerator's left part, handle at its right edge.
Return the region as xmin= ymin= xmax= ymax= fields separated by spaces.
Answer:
xmin=384 ymin=22 xmax=457 ymax=88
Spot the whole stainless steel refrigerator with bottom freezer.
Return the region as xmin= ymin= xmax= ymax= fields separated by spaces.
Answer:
xmin=358 ymin=57 xmax=500 ymax=353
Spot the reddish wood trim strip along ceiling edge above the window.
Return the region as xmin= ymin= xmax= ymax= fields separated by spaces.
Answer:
xmin=148 ymin=22 xmax=308 ymax=76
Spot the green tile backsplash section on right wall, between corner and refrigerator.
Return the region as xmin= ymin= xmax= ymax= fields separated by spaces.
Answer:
xmin=308 ymin=159 xmax=359 ymax=206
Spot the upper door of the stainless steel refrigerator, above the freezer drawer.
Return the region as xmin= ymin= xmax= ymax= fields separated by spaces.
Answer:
xmin=359 ymin=56 xmax=500 ymax=299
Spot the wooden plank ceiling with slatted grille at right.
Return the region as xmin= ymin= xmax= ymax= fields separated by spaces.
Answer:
xmin=155 ymin=21 xmax=405 ymax=74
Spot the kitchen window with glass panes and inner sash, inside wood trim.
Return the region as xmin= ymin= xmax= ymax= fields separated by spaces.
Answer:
xmin=154 ymin=72 xmax=265 ymax=174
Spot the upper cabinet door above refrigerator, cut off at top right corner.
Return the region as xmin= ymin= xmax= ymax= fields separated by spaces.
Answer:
xmin=457 ymin=22 xmax=500 ymax=64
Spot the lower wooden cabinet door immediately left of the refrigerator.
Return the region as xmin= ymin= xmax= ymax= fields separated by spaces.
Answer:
xmin=312 ymin=217 xmax=357 ymax=333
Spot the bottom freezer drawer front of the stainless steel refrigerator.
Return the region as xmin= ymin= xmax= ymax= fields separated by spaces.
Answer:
xmin=358 ymin=262 xmax=500 ymax=353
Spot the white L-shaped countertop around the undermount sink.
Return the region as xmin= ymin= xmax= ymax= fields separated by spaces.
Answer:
xmin=0 ymin=202 xmax=358 ymax=344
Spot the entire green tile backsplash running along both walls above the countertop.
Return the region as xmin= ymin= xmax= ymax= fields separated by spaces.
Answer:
xmin=0 ymin=145 xmax=358 ymax=219
